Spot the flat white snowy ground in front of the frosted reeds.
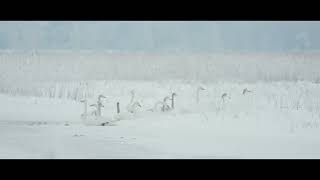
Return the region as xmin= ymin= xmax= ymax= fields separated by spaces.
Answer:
xmin=0 ymin=81 xmax=320 ymax=158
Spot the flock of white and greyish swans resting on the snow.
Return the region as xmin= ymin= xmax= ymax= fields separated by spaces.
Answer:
xmin=80 ymin=86 xmax=252 ymax=126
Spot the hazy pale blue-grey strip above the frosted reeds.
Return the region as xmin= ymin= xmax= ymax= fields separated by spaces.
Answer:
xmin=0 ymin=21 xmax=320 ymax=51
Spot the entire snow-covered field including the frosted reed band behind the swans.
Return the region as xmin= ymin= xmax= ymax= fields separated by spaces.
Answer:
xmin=0 ymin=51 xmax=320 ymax=158
